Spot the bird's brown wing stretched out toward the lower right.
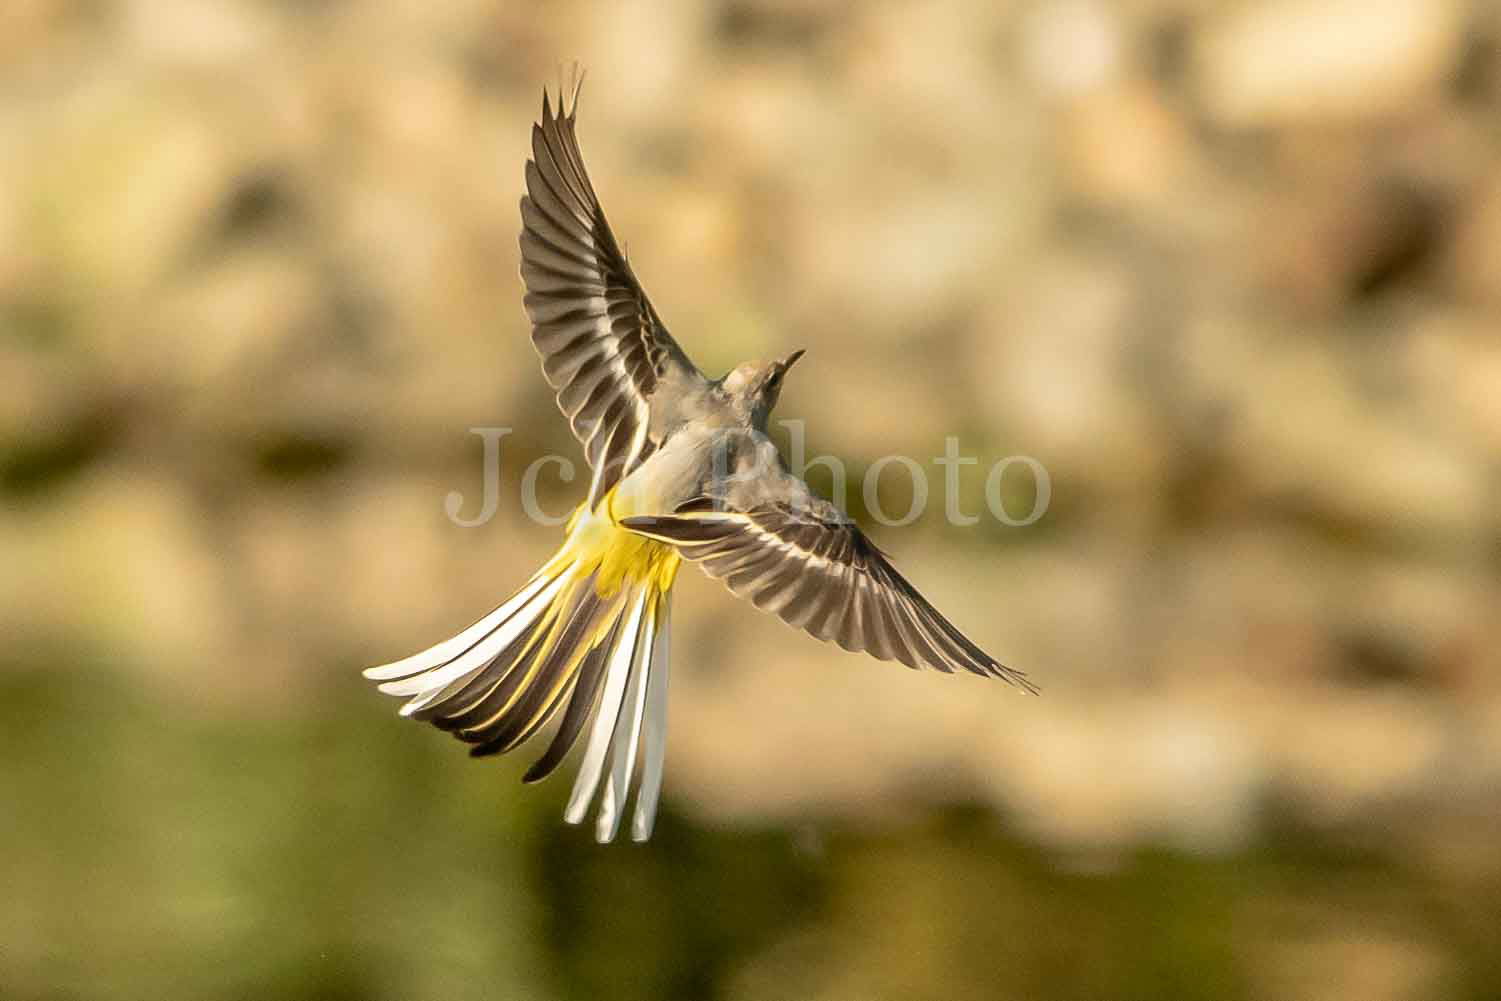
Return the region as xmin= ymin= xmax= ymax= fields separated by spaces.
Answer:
xmin=621 ymin=498 xmax=1037 ymax=693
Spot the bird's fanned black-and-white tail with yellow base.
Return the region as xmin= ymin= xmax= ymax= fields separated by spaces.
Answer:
xmin=365 ymin=498 xmax=680 ymax=842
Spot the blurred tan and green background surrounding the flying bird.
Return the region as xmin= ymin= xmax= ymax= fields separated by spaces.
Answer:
xmin=0 ymin=0 xmax=1501 ymax=1001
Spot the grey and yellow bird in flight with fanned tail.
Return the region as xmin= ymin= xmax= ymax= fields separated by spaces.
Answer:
xmin=365 ymin=81 xmax=1036 ymax=842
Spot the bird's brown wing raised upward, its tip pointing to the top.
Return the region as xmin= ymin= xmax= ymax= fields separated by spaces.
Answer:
xmin=521 ymin=87 xmax=701 ymax=506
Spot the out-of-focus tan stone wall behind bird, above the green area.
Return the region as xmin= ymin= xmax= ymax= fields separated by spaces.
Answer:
xmin=0 ymin=0 xmax=1501 ymax=852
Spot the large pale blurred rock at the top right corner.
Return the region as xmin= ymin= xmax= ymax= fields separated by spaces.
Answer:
xmin=1195 ymin=0 xmax=1463 ymax=128
